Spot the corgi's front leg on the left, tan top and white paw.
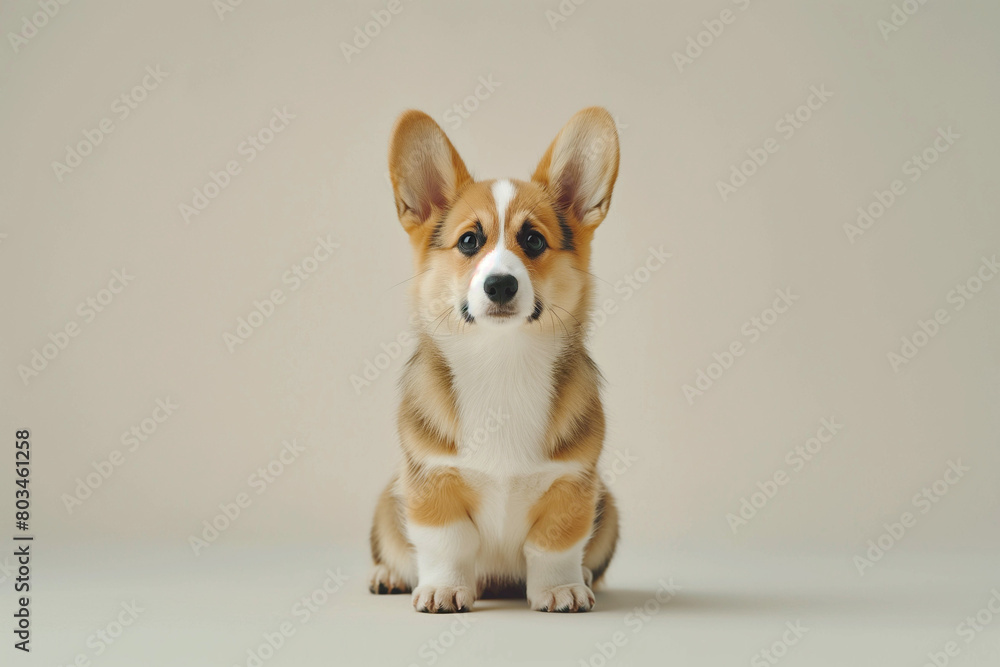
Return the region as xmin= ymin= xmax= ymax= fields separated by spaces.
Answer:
xmin=407 ymin=471 xmax=479 ymax=613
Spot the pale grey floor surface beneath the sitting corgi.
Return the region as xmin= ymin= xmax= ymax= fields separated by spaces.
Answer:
xmin=31 ymin=544 xmax=1000 ymax=667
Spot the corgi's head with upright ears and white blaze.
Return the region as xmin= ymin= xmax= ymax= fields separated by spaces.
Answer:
xmin=389 ymin=107 xmax=618 ymax=334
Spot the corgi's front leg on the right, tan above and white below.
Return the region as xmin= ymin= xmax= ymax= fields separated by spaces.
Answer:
xmin=524 ymin=477 xmax=595 ymax=611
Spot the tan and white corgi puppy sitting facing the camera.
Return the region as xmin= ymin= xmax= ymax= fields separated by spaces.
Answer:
xmin=370 ymin=107 xmax=618 ymax=613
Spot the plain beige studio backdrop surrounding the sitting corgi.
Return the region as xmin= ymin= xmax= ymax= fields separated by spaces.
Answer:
xmin=0 ymin=0 xmax=1000 ymax=664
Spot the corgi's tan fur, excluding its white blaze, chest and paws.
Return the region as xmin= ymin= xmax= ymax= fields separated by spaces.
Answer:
xmin=371 ymin=108 xmax=618 ymax=611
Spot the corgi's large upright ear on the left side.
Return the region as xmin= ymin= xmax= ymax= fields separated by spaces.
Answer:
xmin=389 ymin=109 xmax=472 ymax=233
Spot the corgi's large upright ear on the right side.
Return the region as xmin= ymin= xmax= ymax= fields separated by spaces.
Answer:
xmin=531 ymin=107 xmax=618 ymax=227
